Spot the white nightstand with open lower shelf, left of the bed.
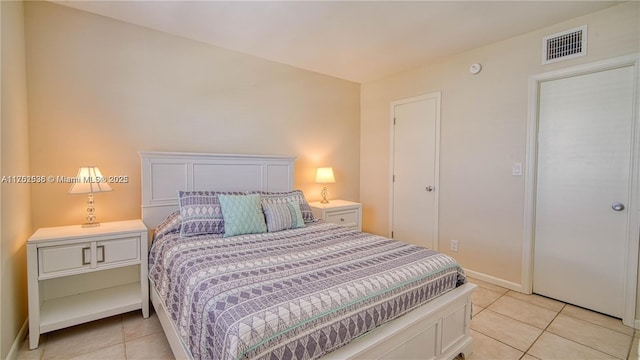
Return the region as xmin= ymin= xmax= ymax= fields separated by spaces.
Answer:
xmin=27 ymin=220 xmax=149 ymax=349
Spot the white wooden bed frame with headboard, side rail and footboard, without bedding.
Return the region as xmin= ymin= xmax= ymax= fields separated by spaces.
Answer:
xmin=140 ymin=152 xmax=475 ymax=360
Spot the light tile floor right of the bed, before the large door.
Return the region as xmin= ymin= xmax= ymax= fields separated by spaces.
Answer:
xmin=468 ymin=279 xmax=640 ymax=360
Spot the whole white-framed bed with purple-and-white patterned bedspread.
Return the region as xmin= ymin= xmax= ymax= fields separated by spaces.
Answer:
xmin=141 ymin=152 xmax=475 ymax=359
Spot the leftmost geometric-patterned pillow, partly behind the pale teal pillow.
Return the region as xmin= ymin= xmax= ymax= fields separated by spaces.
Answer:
xmin=178 ymin=191 xmax=244 ymax=237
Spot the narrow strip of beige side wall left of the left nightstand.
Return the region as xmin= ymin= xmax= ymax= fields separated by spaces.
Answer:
xmin=0 ymin=1 xmax=31 ymax=359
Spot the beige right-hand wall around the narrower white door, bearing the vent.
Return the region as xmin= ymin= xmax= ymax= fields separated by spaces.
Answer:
xmin=360 ymin=2 xmax=640 ymax=285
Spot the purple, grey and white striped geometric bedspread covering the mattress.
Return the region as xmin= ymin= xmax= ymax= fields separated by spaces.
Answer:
xmin=149 ymin=222 xmax=466 ymax=359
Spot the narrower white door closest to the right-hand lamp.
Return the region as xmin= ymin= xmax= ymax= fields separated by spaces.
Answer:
xmin=391 ymin=93 xmax=440 ymax=249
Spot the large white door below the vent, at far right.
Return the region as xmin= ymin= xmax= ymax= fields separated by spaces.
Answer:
xmin=533 ymin=66 xmax=634 ymax=317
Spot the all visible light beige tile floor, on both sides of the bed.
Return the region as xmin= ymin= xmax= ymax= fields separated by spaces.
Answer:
xmin=17 ymin=279 xmax=640 ymax=360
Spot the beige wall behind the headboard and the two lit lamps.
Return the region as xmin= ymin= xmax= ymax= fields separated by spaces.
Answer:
xmin=25 ymin=2 xmax=360 ymax=228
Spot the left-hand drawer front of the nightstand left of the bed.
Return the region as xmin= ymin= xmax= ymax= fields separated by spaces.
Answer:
xmin=38 ymin=242 xmax=91 ymax=276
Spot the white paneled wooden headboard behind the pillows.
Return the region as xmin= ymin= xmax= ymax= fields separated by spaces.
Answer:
xmin=140 ymin=151 xmax=295 ymax=229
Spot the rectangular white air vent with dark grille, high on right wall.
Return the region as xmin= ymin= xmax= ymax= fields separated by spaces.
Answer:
xmin=542 ymin=25 xmax=587 ymax=64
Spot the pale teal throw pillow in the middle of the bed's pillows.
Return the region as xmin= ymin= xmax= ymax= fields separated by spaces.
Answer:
xmin=218 ymin=194 xmax=267 ymax=237
